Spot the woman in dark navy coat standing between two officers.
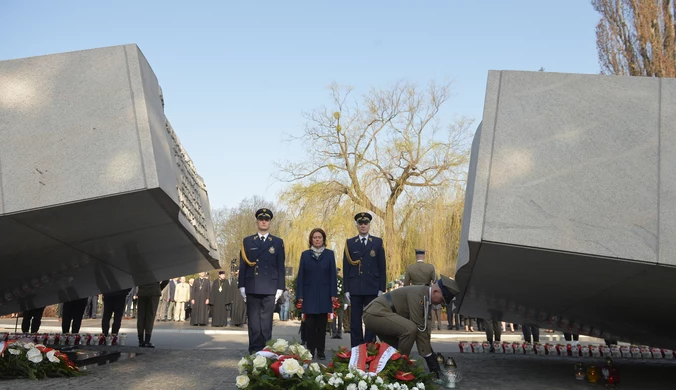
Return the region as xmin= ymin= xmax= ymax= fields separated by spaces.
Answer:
xmin=296 ymin=228 xmax=338 ymax=360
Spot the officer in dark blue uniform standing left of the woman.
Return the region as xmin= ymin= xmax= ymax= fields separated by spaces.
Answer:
xmin=238 ymin=209 xmax=285 ymax=354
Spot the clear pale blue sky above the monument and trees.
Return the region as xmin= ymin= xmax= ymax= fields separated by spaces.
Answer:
xmin=0 ymin=0 xmax=599 ymax=208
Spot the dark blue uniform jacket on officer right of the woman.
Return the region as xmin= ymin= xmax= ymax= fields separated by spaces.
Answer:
xmin=343 ymin=236 xmax=387 ymax=295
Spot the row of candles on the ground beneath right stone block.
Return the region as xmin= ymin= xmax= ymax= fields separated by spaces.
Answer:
xmin=458 ymin=341 xmax=676 ymax=359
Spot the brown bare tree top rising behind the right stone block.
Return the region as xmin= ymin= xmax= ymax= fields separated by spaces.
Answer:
xmin=591 ymin=0 xmax=676 ymax=77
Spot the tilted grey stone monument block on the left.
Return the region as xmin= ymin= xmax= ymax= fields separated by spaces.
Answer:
xmin=0 ymin=45 xmax=218 ymax=314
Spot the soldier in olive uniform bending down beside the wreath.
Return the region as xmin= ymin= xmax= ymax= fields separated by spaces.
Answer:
xmin=364 ymin=275 xmax=459 ymax=376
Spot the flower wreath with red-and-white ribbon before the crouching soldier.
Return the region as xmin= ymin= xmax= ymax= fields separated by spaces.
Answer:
xmin=326 ymin=343 xmax=437 ymax=390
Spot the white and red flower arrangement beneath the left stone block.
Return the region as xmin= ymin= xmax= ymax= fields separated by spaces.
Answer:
xmin=0 ymin=339 xmax=80 ymax=379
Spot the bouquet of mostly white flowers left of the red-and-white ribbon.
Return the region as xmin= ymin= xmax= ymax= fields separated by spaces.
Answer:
xmin=236 ymin=339 xmax=322 ymax=390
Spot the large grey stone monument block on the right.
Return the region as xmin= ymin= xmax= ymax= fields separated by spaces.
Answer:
xmin=457 ymin=71 xmax=676 ymax=348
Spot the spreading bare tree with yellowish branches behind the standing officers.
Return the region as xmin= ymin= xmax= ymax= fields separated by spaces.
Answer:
xmin=281 ymin=83 xmax=469 ymax=277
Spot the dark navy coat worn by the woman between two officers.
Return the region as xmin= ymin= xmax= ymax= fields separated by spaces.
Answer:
xmin=296 ymin=249 xmax=338 ymax=314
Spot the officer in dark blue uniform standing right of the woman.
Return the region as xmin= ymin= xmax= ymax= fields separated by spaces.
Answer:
xmin=343 ymin=213 xmax=387 ymax=347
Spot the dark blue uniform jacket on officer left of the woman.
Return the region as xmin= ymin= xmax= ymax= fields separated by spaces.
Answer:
xmin=238 ymin=234 xmax=286 ymax=295
